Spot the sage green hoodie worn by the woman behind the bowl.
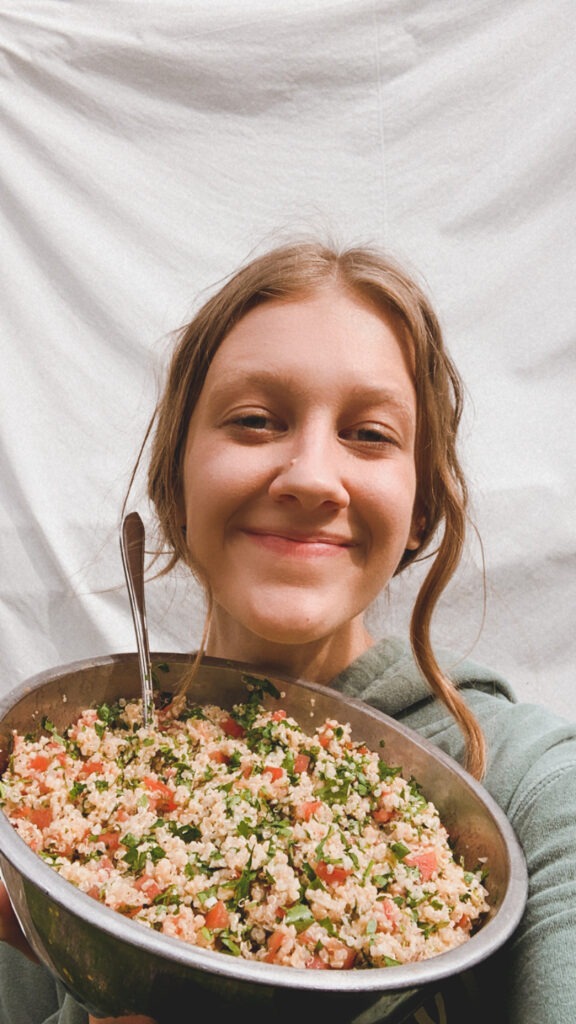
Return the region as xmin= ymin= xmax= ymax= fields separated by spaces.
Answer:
xmin=0 ymin=640 xmax=576 ymax=1024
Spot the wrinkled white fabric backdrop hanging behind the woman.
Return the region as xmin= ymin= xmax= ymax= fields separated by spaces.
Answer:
xmin=0 ymin=0 xmax=576 ymax=718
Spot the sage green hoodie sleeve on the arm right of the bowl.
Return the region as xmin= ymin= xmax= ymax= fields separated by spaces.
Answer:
xmin=487 ymin=706 xmax=576 ymax=1024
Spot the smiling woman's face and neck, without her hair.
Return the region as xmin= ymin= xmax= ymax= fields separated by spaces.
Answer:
xmin=183 ymin=287 xmax=418 ymax=678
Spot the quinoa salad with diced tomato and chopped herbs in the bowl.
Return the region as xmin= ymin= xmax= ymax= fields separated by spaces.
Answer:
xmin=0 ymin=688 xmax=488 ymax=969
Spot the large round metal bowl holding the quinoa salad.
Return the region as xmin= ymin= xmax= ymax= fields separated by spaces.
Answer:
xmin=0 ymin=653 xmax=527 ymax=1024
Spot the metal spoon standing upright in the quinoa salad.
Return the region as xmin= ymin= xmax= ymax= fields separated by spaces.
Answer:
xmin=120 ymin=512 xmax=154 ymax=726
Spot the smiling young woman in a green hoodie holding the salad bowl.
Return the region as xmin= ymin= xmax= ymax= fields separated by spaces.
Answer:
xmin=0 ymin=244 xmax=576 ymax=1024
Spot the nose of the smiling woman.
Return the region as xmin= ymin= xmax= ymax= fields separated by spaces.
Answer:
xmin=269 ymin=438 xmax=349 ymax=511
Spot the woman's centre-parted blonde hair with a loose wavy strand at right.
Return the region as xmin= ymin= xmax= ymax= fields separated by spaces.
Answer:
xmin=141 ymin=242 xmax=486 ymax=778
